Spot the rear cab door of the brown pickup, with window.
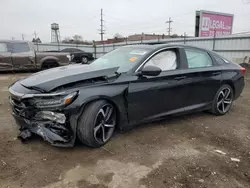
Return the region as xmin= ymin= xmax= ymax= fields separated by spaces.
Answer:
xmin=8 ymin=42 xmax=36 ymax=70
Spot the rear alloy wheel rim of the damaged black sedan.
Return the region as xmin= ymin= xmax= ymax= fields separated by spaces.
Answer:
xmin=217 ymin=87 xmax=233 ymax=114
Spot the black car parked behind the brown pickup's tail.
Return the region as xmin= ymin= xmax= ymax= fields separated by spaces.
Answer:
xmin=62 ymin=48 xmax=94 ymax=64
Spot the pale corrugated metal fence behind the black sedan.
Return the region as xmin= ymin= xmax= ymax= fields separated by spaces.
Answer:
xmin=36 ymin=35 xmax=250 ymax=63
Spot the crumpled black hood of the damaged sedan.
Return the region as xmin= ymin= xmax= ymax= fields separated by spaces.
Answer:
xmin=19 ymin=64 xmax=118 ymax=92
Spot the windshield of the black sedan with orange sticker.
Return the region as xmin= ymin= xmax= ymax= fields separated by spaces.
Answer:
xmin=91 ymin=47 xmax=149 ymax=73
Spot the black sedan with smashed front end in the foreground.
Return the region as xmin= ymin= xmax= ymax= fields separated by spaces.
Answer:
xmin=9 ymin=44 xmax=245 ymax=147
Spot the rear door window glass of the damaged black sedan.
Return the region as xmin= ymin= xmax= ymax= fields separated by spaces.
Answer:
xmin=185 ymin=49 xmax=213 ymax=68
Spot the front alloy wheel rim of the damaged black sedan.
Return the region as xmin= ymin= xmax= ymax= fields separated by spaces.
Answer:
xmin=94 ymin=104 xmax=116 ymax=143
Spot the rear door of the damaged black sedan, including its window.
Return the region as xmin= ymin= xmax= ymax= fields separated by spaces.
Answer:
xmin=181 ymin=48 xmax=222 ymax=110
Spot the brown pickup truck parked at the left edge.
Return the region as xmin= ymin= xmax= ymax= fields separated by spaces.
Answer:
xmin=0 ymin=40 xmax=71 ymax=71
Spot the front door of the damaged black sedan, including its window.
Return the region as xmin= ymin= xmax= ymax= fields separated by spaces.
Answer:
xmin=128 ymin=49 xmax=187 ymax=124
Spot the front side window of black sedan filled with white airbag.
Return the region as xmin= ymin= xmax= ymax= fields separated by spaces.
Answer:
xmin=145 ymin=50 xmax=177 ymax=71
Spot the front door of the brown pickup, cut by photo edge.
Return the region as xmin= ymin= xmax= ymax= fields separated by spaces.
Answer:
xmin=0 ymin=42 xmax=12 ymax=70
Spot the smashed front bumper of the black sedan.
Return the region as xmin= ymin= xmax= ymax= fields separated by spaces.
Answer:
xmin=10 ymin=94 xmax=77 ymax=147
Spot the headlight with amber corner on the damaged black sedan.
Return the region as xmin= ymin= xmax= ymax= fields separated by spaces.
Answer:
xmin=34 ymin=92 xmax=78 ymax=108
